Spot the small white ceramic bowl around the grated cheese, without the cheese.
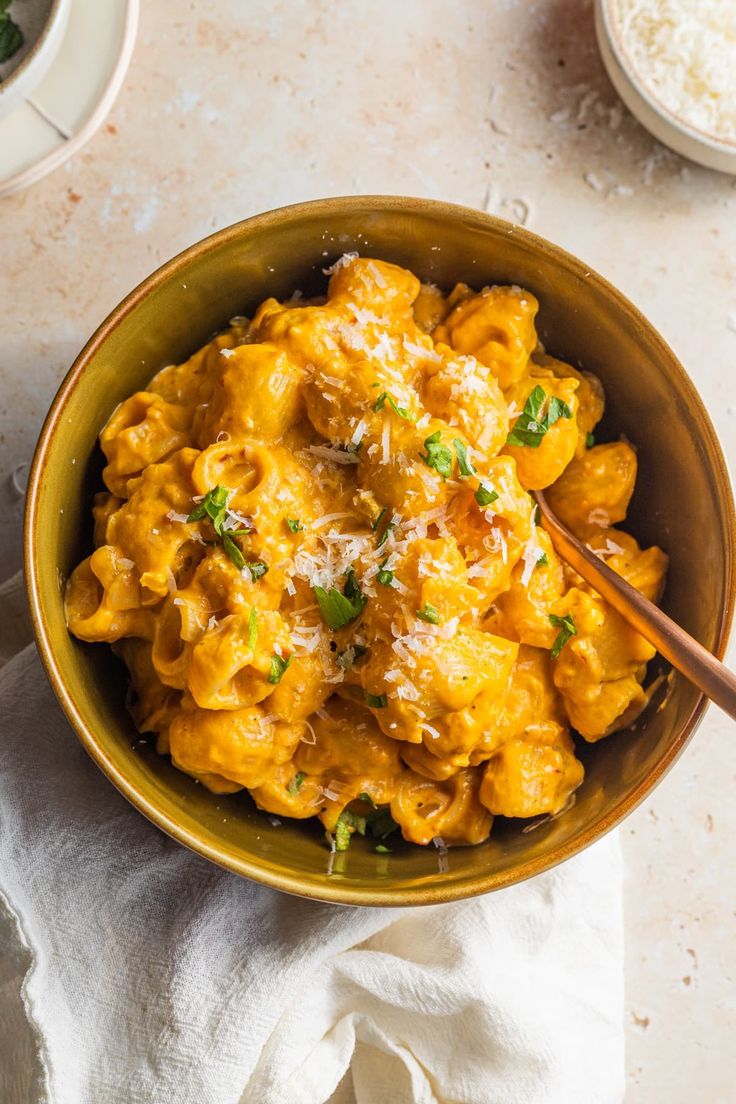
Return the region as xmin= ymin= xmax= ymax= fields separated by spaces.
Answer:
xmin=595 ymin=0 xmax=736 ymax=173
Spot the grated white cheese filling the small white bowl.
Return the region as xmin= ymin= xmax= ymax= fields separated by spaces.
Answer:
xmin=614 ymin=0 xmax=736 ymax=144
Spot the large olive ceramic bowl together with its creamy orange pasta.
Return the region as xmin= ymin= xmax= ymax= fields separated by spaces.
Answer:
xmin=25 ymin=197 xmax=734 ymax=907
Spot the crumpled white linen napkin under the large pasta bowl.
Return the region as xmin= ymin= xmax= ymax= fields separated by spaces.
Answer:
xmin=0 ymin=578 xmax=623 ymax=1104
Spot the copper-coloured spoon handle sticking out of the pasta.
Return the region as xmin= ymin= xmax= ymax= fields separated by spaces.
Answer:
xmin=534 ymin=491 xmax=736 ymax=720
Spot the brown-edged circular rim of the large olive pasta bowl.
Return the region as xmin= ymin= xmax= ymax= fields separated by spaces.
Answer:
xmin=23 ymin=195 xmax=736 ymax=906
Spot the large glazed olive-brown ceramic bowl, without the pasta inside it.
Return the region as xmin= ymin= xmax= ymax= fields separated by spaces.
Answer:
xmin=25 ymin=197 xmax=734 ymax=905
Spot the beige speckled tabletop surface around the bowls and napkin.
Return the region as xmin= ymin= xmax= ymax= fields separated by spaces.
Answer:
xmin=0 ymin=0 xmax=736 ymax=1104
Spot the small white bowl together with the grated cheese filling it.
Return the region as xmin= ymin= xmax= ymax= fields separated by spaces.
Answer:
xmin=595 ymin=0 xmax=736 ymax=173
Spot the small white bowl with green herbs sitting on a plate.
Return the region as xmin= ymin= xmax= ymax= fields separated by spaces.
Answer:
xmin=0 ymin=0 xmax=72 ymax=115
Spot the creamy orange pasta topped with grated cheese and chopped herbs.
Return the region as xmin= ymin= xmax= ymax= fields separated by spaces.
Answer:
xmin=65 ymin=253 xmax=668 ymax=853
